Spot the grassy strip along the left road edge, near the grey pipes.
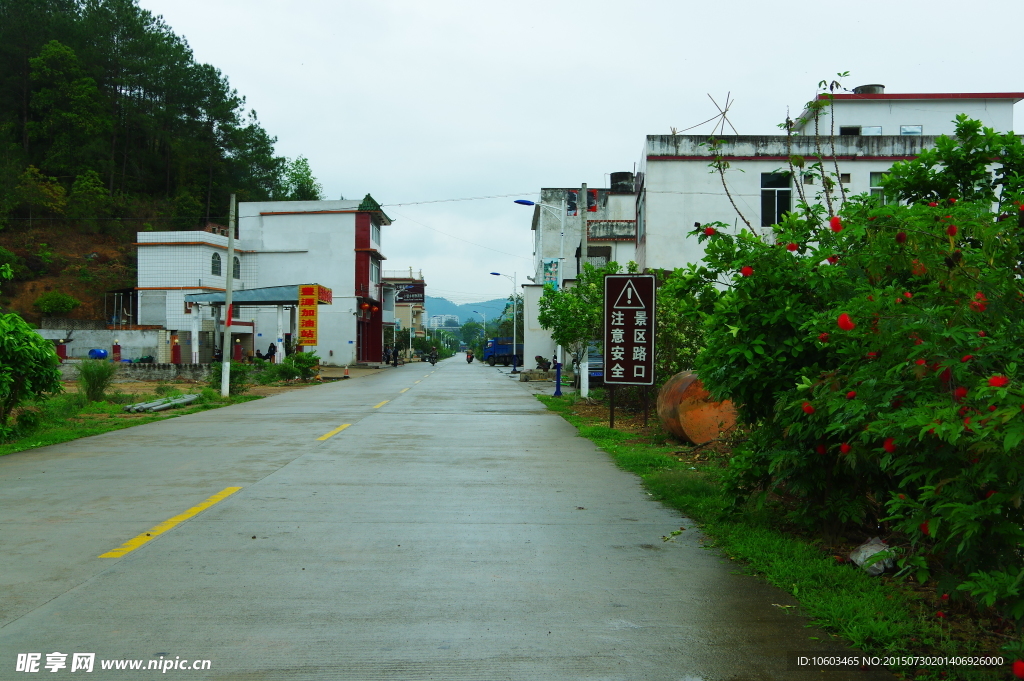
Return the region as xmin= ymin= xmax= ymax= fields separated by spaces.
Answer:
xmin=0 ymin=389 xmax=259 ymax=457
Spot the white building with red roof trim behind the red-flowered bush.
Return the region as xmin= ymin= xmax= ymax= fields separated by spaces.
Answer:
xmin=636 ymin=85 xmax=1024 ymax=271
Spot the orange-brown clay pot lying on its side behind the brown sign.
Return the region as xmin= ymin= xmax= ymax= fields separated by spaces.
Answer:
xmin=657 ymin=372 xmax=736 ymax=444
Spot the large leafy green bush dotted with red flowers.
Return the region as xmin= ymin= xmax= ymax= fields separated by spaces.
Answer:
xmin=689 ymin=120 xmax=1024 ymax=620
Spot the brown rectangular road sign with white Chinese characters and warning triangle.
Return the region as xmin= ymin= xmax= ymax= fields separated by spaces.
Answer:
xmin=604 ymin=274 xmax=655 ymax=386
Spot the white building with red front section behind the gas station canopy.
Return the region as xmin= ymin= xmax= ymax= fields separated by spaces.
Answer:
xmin=137 ymin=195 xmax=393 ymax=366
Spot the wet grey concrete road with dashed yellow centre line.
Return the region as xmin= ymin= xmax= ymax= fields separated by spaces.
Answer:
xmin=0 ymin=357 xmax=889 ymax=681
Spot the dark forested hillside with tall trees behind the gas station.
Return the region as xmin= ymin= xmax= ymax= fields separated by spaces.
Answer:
xmin=0 ymin=0 xmax=321 ymax=323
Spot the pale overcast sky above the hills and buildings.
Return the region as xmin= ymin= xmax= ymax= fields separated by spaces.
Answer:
xmin=140 ymin=0 xmax=1024 ymax=302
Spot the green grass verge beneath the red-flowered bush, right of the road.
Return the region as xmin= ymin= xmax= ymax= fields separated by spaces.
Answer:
xmin=538 ymin=395 xmax=1013 ymax=680
